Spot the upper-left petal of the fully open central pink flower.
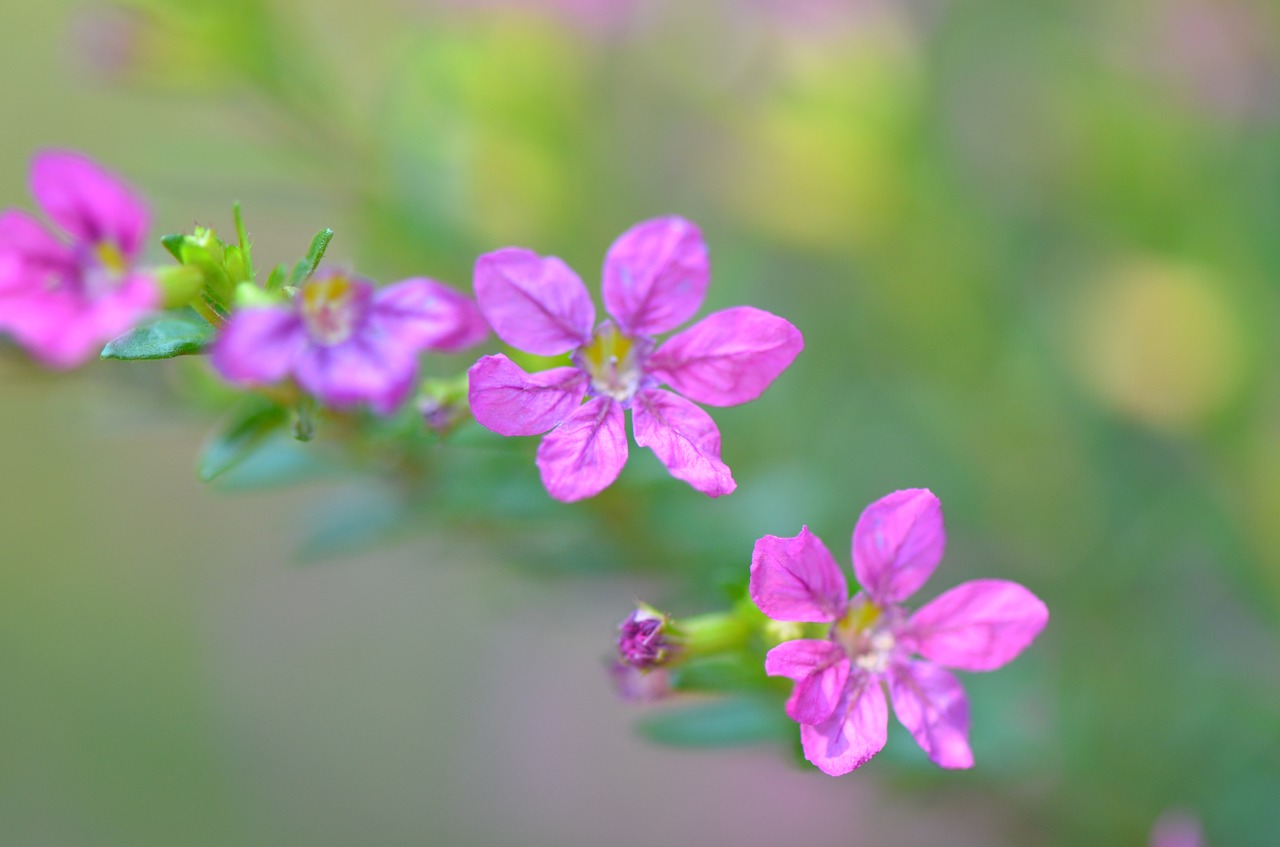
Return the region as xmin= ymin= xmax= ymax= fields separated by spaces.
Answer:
xmin=475 ymin=247 xmax=595 ymax=356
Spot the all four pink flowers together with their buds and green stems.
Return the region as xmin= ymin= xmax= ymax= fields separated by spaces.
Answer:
xmin=0 ymin=151 xmax=1048 ymax=774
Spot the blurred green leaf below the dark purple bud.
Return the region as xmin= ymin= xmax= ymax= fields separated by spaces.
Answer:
xmin=636 ymin=697 xmax=795 ymax=747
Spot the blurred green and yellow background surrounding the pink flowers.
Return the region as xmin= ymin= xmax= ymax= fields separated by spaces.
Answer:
xmin=0 ymin=0 xmax=1280 ymax=847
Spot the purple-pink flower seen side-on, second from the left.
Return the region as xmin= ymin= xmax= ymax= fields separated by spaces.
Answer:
xmin=211 ymin=269 xmax=489 ymax=415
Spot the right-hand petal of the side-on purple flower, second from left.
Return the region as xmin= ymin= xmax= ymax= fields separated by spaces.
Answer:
xmin=372 ymin=276 xmax=489 ymax=352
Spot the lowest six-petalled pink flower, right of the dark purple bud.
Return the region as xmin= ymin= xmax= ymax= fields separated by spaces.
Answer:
xmin=750 ymin=489 xmax=1048 ymax=775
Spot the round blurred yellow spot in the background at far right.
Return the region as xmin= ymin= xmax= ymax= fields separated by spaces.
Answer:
xmin=1071 ymin=261 xmax=1245 ymax=430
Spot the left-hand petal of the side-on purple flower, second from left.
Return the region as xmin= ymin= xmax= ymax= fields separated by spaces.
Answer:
xmin=209 ymin=306 xmax=306 ymax=385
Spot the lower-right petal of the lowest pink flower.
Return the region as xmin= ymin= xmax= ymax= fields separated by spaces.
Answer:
xmin=888 ymin=661 xmax=973 ymax=768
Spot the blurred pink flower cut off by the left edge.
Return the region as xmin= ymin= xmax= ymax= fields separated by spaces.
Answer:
xmin=0 ymin=151 xmax=160 ymax=367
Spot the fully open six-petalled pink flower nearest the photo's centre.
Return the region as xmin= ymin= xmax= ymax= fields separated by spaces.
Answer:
xmin=470 ymin=218 xmax=804 ymax=502
